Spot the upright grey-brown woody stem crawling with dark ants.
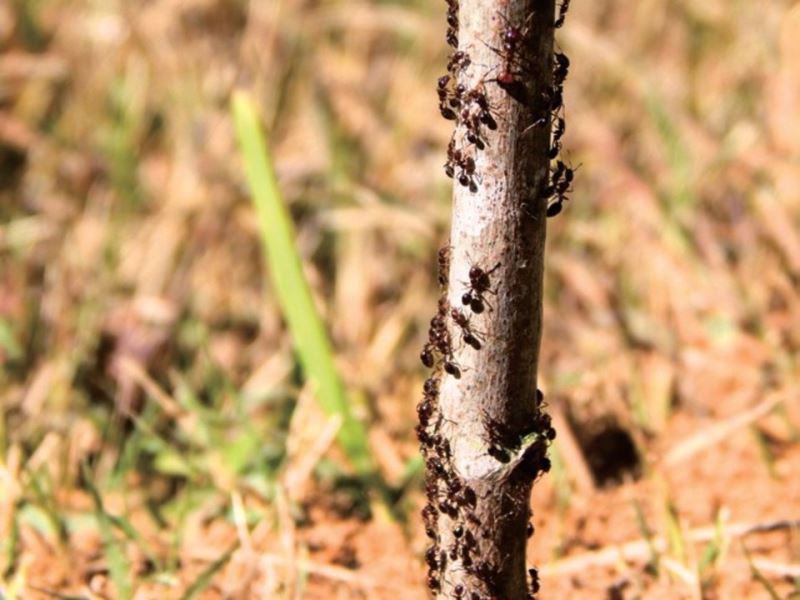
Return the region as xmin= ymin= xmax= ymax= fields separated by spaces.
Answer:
xmin=417 ymin=0 xmax=560 ymax=600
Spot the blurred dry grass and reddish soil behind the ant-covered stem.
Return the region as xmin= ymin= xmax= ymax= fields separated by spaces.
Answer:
xmin=0 ymin=0 xmax=800 ymax=599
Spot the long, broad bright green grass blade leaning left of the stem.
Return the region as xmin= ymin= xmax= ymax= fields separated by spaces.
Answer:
xmin=232 ymin=92 xmax=374 ymax=476
